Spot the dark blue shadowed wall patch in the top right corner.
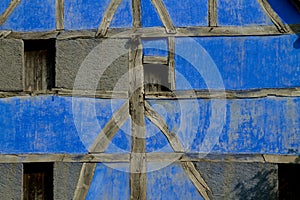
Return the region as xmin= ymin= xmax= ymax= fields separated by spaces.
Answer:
xmin=268 ymin=0 xmax=300 ymax=49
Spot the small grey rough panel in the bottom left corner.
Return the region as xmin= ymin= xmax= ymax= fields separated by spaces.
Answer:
xmin=0 ymin=164 xmax=23 ymax=200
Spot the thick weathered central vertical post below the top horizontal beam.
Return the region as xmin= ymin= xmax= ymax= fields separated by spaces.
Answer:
xmin=129 ymin=38 xmax=146 ymax=200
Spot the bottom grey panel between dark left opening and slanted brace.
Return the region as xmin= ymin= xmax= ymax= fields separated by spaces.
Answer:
xmin=53 ymin=162 xmax=82 ymax=200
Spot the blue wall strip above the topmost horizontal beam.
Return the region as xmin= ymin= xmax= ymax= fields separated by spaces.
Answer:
xmin=0 ymin=0 xmax=300 ymax=31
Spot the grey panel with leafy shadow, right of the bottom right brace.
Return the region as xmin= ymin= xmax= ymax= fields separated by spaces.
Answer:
xmin=196 ymin=162 xmax=278 ymax=200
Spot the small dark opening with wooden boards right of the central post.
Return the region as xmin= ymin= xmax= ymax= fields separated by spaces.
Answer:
xmin=144 ymin=64 xmax=170 ymax=92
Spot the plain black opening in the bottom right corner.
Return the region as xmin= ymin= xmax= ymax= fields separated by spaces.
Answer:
xmin=278 ymin=164 xmax=300 ymax=200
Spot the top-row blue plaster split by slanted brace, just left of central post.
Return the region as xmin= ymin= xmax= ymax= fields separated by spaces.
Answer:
xmin=65 ymin=0 xmax=132 ymax=30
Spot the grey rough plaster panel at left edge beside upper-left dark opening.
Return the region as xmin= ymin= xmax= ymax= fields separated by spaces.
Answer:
xmin=0 ymin=39 xmax=24 ymax=91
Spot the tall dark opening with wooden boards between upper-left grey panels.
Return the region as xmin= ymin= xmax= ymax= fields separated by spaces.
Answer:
xmin=24 ymin=40 xmax=55 ymax=92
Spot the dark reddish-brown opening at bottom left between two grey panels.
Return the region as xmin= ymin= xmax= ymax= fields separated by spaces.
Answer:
xmin=23 ymin=163 xmax=53 ymax=200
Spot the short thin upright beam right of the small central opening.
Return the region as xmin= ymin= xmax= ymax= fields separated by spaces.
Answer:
xmin=168 ymin=37 xmax=176 ymax=91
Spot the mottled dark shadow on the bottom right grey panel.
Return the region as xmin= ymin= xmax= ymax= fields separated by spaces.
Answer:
xmin=234 ymin=169 xmax=278 ymax=200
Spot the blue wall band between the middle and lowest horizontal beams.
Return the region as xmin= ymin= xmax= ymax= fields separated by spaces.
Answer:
xmin=0 ymin=96 xmax=300 ymax=154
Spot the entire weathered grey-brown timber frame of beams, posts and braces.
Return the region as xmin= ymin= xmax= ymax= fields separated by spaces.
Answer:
xmin=0 ymin=0 xmax=300 ymax=200
